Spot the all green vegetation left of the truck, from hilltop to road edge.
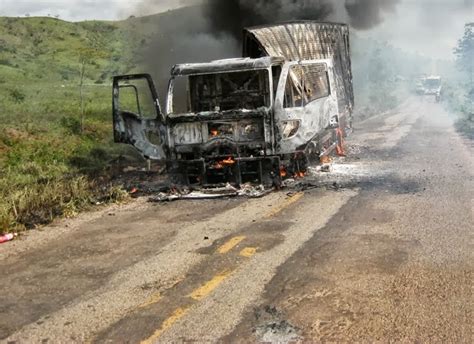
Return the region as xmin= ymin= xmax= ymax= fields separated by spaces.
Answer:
xmin=0 ymin=18 xmax=144 ymax=232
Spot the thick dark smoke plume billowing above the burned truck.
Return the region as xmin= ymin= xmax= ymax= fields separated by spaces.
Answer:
xmin=138 ymin=0 xmax=400 ymax=96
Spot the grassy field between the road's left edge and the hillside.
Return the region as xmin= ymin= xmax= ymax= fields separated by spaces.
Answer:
xmin=0 ymin=85 xmax=131 ymax=232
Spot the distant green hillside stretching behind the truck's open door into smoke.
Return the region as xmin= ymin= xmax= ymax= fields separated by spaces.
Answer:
xmin=0 ymin=7 xmax=205 ymax=84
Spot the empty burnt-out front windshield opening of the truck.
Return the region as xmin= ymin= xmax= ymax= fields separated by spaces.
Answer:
xmin=172 ymin=69 xmax=271 ymax=114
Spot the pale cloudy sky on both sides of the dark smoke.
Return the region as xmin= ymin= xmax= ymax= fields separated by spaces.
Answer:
xmin=0 ymin=0 xmax=474 ymax=59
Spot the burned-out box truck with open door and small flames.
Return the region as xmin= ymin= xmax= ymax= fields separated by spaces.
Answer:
xmin=113 ymin=21 xmax=354 ymax=186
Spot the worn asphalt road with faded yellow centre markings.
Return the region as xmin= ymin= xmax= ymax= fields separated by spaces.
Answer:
xmin=0 ymin=100 xmax=474 ymax=343
